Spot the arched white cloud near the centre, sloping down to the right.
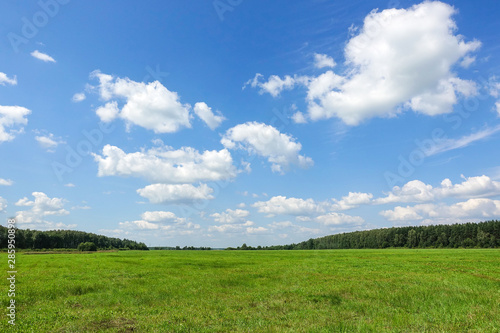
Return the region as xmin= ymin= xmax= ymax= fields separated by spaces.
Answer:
xmin=221 ymin=122 xmax=313 ymax=173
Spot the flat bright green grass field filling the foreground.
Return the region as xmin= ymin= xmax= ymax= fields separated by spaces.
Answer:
xmin=0 ymin=249 xmax=500 ymax=332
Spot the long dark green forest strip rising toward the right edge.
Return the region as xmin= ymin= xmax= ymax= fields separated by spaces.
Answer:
xmin=237 ymin=221 xmax=500 ymax=250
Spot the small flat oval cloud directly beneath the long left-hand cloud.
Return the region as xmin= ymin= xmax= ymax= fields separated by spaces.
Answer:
xmin=137 ymin=184 xmax=214 ymax=204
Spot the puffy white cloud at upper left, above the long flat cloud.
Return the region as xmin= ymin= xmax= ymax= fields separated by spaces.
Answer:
xmin=91 ymin=71 xmax=191 ymax=133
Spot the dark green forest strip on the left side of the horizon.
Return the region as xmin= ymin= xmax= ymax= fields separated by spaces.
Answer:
xmin=0 ymin=226 xmax=148 ymax=250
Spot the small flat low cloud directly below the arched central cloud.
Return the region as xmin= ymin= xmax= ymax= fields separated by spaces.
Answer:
xmin=252 ymin=196 xmax=329 ymax=216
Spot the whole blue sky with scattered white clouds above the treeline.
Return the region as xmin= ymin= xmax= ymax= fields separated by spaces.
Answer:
xmin=0 ymin=0 xmax=500 ymax=247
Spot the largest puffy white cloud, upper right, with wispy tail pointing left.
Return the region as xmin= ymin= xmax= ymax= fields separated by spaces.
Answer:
xmin=247 ymin=1 xmax=481 ymax=125
